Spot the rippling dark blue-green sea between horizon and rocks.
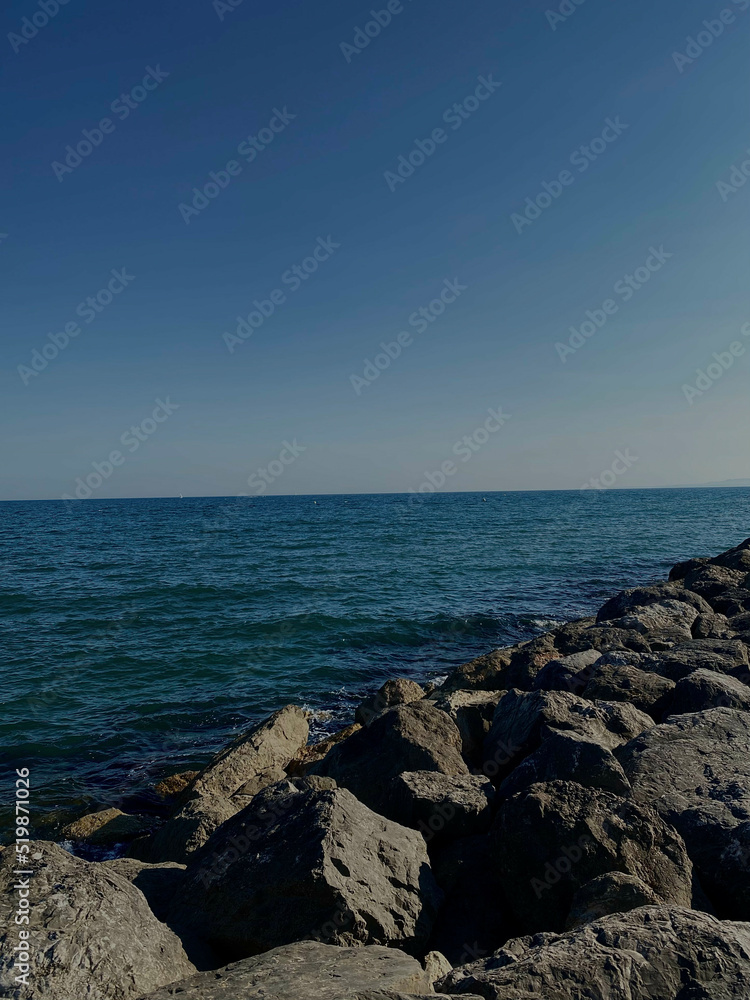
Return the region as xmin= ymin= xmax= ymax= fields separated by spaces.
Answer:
xmin=0 ymin=489 xmax=750 ymax=828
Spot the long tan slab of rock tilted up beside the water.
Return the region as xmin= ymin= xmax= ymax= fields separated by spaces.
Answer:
xmin=144 ymin=705 xmax=309 ymax=863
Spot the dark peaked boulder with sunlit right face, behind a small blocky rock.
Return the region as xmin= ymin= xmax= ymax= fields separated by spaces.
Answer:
xmin=311 ymin=701 xmax=469 ymax=816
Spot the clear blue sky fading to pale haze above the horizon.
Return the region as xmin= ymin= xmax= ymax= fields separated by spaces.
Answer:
xmin=0 ymin=0 xmax=750 ymax=499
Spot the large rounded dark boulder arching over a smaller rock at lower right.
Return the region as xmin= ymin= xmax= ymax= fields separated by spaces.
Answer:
xmin=490 ymin=781 xmax=692 ymax=932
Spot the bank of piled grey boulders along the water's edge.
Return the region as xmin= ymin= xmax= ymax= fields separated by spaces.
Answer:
xmin=7 ymin=539 xmax=750 ymax=1000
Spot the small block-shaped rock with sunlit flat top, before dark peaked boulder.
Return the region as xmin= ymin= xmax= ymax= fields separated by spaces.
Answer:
xmin=390 ymin=765 xmax=496 ymax=846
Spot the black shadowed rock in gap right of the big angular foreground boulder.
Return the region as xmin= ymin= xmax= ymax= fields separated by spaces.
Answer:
xmin=429 ymin=835 xmax=514 ymax=966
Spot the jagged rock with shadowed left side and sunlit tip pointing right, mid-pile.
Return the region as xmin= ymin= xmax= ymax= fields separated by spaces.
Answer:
xmin=483 ymin=690 xmax=654 ymax=782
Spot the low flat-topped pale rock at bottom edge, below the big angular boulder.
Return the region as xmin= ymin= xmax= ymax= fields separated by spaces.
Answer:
xmin=135 ymin=941 xmax=434 ymax=1000
